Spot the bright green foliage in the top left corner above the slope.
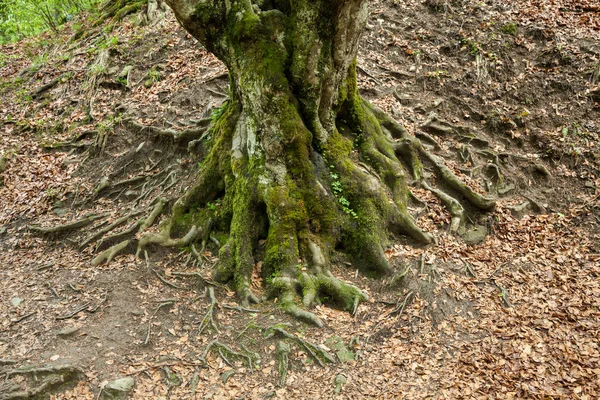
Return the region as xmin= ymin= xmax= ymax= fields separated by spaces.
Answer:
xmin=0 ymin=0 xmax=99 ymax=44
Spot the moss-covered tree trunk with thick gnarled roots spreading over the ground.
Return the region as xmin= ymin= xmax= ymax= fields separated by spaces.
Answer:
xmin=139 ymin=0 xmax=494 ymax=326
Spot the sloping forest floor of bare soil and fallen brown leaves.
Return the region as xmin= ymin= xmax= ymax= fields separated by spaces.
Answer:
xmin=0 ymin=0 xmax=600 ymax=399
